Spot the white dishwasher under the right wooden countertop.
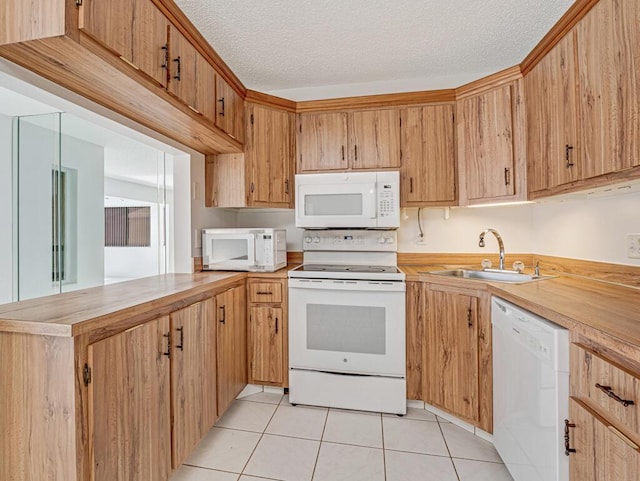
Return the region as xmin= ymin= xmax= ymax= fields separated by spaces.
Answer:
xmin=491 ymin=297 xmax=569 ymax=481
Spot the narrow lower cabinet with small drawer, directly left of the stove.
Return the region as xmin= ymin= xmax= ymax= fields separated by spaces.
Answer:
xmin=247 ymin=278 xmax=288 ymax=387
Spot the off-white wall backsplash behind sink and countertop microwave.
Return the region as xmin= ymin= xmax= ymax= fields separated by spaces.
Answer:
xmin=225 ymin=189 xmax=640 ymax=265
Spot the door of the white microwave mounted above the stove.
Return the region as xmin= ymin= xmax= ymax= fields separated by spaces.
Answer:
xmin=296 ymin=174 xmax=378 ymax=228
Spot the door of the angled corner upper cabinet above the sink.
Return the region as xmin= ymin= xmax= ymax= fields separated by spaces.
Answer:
xmin=457 ymin=84 xmax=515 ymax=200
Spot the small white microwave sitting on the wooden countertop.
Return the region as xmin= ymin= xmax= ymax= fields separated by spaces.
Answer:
xmin=202 ymin=228 xmax=287 ymax=272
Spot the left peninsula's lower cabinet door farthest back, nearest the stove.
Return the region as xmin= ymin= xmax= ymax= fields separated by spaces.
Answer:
xmin=216 ymin=286 xmax=247 ymax=416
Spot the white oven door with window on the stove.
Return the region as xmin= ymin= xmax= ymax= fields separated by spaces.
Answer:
xmin=289 ymin=279 xmax=406 ymax=377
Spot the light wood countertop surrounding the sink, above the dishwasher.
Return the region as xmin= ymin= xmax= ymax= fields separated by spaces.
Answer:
xmin=400 ymin=265 xmax=640 ymax=349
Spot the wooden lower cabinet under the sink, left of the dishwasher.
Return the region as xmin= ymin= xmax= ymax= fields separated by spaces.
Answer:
xmin=422 ymin=284 xmax=493 ymax=432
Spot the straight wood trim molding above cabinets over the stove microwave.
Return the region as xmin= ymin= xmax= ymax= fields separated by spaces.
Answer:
xmin=296 ymin=89 xmax=456 ymax=113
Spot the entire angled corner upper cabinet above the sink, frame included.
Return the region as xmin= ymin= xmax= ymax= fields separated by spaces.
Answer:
xmin=456 ymin=80 xmax=526 ymax=205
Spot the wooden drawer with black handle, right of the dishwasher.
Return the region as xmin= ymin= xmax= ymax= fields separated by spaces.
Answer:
xmin=571 ymin=344 xmax=640 ymax=434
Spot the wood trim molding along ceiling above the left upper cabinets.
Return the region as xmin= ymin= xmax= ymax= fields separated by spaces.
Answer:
xmin=152 ymin=0 xmax=247 ymax=98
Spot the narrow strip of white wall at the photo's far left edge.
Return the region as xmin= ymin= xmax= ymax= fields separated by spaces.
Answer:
xmin=0 ymin=115 xmax=13 ymax=304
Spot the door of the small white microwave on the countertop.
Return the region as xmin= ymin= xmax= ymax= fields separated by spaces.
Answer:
xmin=202 ymin=231 xmax=256 ymax=271
